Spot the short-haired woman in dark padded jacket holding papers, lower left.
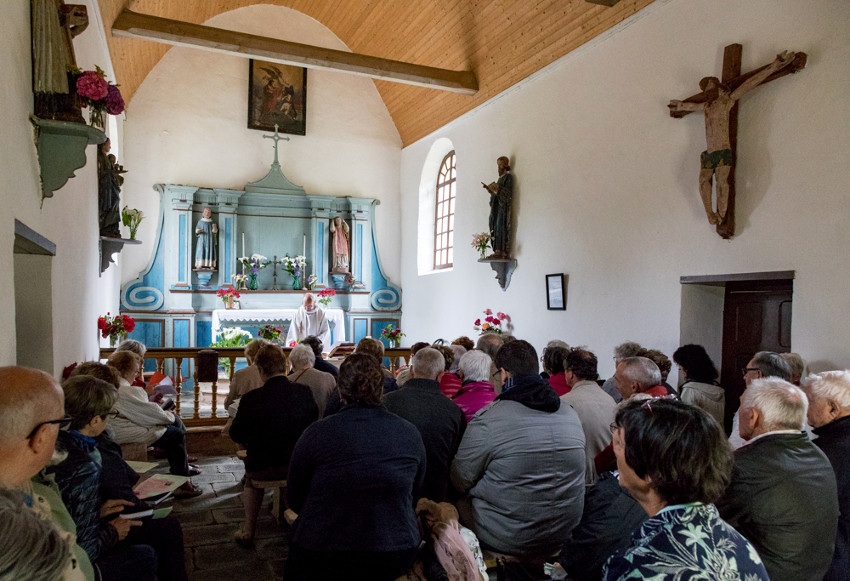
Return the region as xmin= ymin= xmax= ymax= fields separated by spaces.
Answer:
xmin=48 ymin=375 xmax=157 ymax=581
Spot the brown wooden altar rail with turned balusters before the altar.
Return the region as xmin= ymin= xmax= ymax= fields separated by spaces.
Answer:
xmin=100 ymin=347 xmax=410 ymax=427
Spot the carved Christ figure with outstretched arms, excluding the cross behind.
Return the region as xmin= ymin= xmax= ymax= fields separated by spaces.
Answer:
xmin=668 ymin=51 xmax=796 ymax=224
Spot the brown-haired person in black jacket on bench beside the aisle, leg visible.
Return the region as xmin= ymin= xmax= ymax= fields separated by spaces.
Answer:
xmin=230 ymin=345 xmax=319 ymax=546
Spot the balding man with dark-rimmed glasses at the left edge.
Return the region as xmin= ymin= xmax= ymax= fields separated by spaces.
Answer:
xmin=0 ymin=367 xmax=94 ymax=580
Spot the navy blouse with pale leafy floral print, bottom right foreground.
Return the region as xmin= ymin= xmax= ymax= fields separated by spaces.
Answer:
xmin=603 ymin=502 xmax=769 ymax=581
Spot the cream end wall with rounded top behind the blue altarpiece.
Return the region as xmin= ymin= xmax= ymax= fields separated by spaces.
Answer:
xmin=123 ymin=5 xmax=401 ymax=282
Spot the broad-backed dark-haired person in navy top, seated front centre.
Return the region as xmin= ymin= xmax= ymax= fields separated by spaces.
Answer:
xmin=284 ymin=353 xmax=425 ymax=581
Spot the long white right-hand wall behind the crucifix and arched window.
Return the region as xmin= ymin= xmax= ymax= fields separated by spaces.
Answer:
xmin=401 ymin=0 xmax=850 ymax=381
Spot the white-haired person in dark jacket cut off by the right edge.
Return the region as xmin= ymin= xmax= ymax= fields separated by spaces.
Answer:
xmin=803 ymin=369 xmax=850 ymax=581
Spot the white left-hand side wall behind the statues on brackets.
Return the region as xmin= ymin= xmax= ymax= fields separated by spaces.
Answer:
xmin=0 ymin=0 xmax=118 ymax=373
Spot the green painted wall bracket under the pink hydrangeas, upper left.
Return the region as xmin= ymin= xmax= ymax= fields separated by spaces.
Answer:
xmin=30 ymin=116 xmax=106 ymax=199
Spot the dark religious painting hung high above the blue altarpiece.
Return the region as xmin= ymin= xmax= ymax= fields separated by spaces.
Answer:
xmin=248 ymin=59 xmax=307 ymax=135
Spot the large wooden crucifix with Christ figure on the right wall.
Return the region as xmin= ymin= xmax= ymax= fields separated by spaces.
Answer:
xmin=668 ymin=44 xmax=806 ymax=238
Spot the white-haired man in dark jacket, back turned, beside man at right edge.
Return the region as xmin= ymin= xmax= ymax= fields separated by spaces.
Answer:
xmin=717 ymin=377 xmax=838 ymax=581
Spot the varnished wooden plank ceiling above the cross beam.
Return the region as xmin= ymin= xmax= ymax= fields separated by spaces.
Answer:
xmin=99 ymin=0 xmax=653 ymax=146
